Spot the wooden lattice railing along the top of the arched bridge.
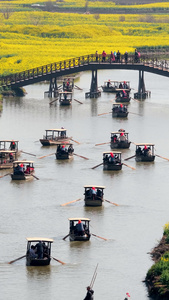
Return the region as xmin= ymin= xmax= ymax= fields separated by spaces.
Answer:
xmin=0 ymin=54 xmax=169 ymax=87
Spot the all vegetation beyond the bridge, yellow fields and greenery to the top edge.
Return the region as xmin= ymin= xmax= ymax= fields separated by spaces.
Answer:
xmin=0 ymin=0 xmax=169 ymax=76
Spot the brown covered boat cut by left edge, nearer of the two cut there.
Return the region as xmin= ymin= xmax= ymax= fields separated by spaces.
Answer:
xmin=0 ymin=150 xmax=17 ymax=170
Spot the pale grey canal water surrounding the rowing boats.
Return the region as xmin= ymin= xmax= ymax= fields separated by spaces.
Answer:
xmin=0 ymin=70 xmax=169 ymax=300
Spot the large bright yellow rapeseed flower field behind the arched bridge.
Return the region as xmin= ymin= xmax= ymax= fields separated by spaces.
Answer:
xmin=0 ymin=8 xmax=169 ymax=75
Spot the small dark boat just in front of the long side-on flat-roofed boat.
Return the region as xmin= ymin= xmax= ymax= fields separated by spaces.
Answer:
xmin=56 ymin=143 xmax=74 ymax=159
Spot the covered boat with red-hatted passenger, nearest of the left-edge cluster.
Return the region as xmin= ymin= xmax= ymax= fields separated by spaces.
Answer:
xmin=11 ymin=160 xmax=34 ymax=180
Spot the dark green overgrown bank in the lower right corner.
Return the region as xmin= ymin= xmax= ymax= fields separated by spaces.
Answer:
xmin=145 ymin=223 xmax=169 ymax=300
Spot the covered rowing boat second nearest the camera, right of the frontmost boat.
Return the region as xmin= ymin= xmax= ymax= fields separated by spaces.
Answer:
xmin=69 ymin=218 xmax=91 ymax=242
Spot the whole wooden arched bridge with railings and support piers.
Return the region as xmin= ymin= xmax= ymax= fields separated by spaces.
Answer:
xmin=0 ymin=54 xmax=169 ymax=99
